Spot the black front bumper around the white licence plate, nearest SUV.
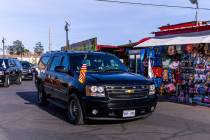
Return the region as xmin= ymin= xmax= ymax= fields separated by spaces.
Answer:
xmin=82 ymin=95 xmax=157 ymax=120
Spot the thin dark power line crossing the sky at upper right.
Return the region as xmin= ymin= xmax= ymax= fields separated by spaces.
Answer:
xmin=96 ymin=0 xmax=210 ymax=11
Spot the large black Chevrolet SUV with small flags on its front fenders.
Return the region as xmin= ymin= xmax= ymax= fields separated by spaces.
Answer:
xmin=35 ymin=51 xmax=157 ymax=124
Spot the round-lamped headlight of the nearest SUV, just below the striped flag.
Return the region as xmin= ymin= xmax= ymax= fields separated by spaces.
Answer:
xmin=86 ymin=86 xmax=105 ymax=97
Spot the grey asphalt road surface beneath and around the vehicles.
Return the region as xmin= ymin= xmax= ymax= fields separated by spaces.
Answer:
xmin=0 ymin=81 xmax=210 ymax=140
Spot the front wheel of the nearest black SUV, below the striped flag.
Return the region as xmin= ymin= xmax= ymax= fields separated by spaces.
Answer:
xmin=67 ymin=94 xmax=84 ymax=125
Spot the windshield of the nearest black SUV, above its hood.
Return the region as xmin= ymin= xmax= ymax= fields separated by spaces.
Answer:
xmin=70 ymin=54 xmax=127 ymax=72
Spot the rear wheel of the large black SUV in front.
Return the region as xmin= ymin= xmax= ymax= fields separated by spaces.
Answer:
xmin=37 ymin=84 xmax=48 ymax=106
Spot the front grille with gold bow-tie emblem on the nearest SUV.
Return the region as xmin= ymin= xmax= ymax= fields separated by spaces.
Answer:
xmin=106 ymin=85 xmax=149 ymax=100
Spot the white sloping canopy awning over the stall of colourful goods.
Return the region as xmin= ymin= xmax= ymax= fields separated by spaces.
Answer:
xmin=134 ymin=31 xmax=210 ymax=48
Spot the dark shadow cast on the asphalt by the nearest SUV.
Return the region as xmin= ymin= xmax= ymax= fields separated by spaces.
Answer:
xmin=16 ymin=91 xmax=135 ymax=125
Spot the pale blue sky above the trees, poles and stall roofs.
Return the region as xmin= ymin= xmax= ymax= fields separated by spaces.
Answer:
xmin=0 ymin=0 xmax=210 ymax=51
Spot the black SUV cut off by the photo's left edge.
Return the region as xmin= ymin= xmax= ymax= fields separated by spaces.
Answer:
xmin=0 ymin=58 xmax=22 ymax=87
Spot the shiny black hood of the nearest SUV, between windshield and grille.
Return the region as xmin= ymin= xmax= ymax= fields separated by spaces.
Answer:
xmin=87 ymin=72 xmax=153 ymax=85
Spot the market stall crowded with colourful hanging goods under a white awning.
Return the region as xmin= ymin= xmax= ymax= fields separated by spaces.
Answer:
xmin=133 ymin=21 xmax=210 ymax=106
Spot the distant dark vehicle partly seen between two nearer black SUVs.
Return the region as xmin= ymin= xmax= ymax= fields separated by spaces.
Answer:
xmin=20 ymin=61 xmax=33 ymax=80
